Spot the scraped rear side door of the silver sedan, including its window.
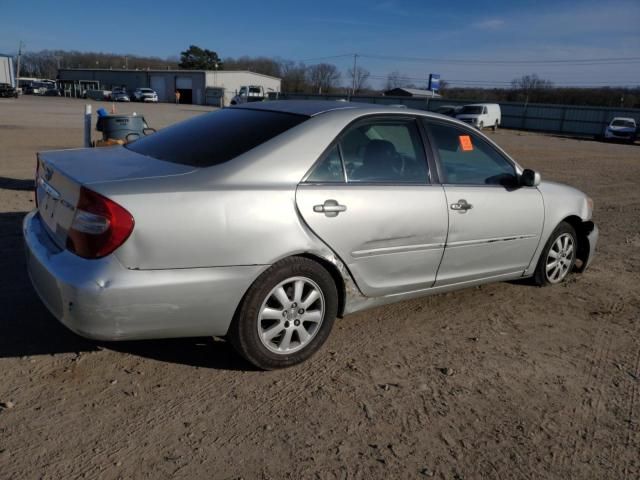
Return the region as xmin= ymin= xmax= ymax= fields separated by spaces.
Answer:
xmin=296 ymin=116 xmax=447 ymax=296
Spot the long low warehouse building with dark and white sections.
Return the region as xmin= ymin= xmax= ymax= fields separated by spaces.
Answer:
xmin=58 ymin=68 xmax=282 ymax=106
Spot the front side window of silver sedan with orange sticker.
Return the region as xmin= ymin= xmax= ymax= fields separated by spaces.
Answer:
xmin=428 ymin=123 xmax=517 ymax=186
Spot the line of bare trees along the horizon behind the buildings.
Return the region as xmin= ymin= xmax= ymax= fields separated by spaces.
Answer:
xmin=12 ymin=45 xmax=640 ymax=108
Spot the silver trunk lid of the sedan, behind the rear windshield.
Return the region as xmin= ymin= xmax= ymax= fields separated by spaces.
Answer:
xmin=36 ymin=147 xmax=195 ymax=248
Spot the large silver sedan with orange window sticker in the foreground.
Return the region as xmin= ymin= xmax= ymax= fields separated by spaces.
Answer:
xmin=23 ymin=101 xmax=598 ymax=369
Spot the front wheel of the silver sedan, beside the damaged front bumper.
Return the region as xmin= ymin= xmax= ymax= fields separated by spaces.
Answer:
xmin=533 ymin=222 xmax=578 ymax=286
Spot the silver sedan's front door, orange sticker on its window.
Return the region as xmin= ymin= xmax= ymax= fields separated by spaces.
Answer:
xmin=425 ymin=120 xmax=544 ymax=286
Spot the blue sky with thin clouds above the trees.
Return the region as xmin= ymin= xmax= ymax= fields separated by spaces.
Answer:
xmin=0 ymin=0 xmax=640 ymax=87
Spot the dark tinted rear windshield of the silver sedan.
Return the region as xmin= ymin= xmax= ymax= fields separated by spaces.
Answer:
xmin=126 ymin=108 xmax=308 ymax=167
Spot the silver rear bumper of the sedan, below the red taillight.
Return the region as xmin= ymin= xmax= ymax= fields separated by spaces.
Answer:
xmin=23 ymin=211 xmax=268 ymax=340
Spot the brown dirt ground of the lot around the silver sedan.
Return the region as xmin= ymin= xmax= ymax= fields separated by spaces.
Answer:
xmin=0 ymin=97 xmax=640 ymax=480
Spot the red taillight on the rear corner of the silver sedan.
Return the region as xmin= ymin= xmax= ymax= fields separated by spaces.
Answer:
xmin=67 ymin=187 xmax=134 ymax=258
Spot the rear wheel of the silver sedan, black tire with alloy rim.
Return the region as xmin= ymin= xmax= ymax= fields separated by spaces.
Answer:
xmin=228 ymin=257 xmax=338 ymax=370
